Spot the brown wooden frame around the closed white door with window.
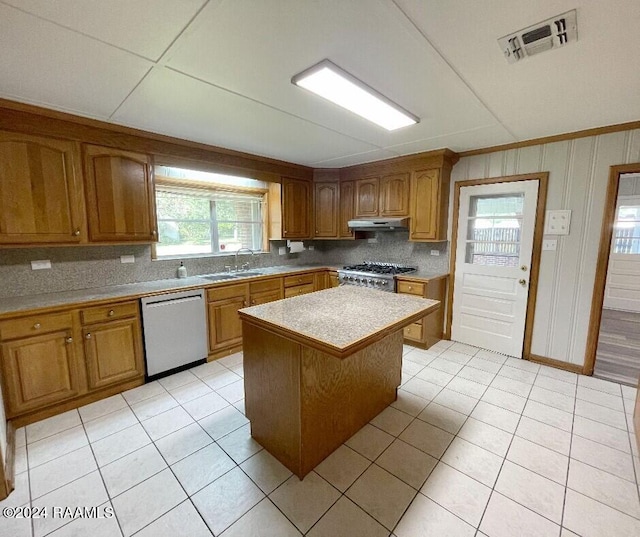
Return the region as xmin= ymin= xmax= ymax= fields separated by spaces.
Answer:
xmin=445 ymin=172 xmax=549 ymax=360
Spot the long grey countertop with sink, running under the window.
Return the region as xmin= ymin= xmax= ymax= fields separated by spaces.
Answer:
xmin=0 ymin=265 xmax=334 ymax=316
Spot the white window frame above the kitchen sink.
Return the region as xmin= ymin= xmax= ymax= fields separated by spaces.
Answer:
xmin=151 ymin=173 xmax=269 ymax=261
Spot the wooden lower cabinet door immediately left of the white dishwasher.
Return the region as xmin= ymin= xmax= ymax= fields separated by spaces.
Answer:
xmin=82 ymin=318 xmax=144 ymax=389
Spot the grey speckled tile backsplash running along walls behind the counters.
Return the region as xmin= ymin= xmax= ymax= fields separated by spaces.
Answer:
xmin=0 ymin=232 xmax=448 ymax=299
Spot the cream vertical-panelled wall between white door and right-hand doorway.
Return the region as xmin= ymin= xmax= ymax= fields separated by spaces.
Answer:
xmin=449 ymin=130 xmax=640 ymax=365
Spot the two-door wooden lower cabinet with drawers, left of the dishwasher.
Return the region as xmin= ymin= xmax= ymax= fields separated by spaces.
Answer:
xmin=0 ymin=301 xmax=144 ymax=423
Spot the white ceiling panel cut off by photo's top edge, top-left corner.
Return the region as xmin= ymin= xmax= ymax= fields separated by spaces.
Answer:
xmin=0 ymin=0 xmax=206 ymax=60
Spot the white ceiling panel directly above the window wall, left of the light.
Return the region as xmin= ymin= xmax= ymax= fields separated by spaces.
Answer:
xmin=112 ymin=68 xmax=375 ymax=164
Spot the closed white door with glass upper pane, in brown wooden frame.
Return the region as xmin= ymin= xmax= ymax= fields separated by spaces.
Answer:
xmin=451 ymin=180 xmax=538 ymax=358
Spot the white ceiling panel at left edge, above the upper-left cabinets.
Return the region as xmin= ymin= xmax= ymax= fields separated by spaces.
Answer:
xmin=0 ymin=4 xmax=151 ymax=119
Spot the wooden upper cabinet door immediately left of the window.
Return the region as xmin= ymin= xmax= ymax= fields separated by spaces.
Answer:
xmin=84 ymin=145 xmax=157 ymax=242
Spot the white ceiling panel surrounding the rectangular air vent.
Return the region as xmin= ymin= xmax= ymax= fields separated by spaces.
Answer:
xmin=398 ymin=0 xmax=640 ymax=140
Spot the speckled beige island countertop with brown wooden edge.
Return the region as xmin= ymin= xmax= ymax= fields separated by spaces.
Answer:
xmin=238 ymin=285 xmax=440 ymax=358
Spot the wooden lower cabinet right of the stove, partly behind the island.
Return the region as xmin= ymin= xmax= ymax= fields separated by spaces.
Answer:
xmin=396 ymin=276 xmax=448 ymax=349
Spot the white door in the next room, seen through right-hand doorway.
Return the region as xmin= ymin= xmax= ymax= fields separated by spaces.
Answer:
xmin=603 ymin=194 xmax=640 ymax=313
